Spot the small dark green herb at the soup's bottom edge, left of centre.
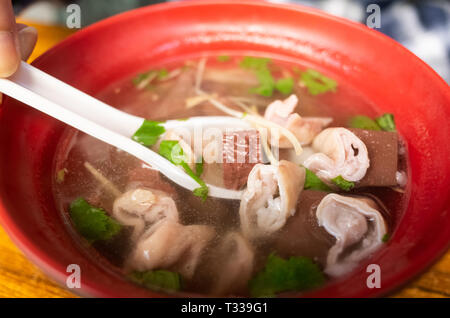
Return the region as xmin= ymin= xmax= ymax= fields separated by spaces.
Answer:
xmin=130 ymin=270 xmax=182 ymax=291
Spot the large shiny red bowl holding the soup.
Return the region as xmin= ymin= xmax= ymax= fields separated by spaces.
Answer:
xmin=0 ymin=1 xmax=450 ymax=297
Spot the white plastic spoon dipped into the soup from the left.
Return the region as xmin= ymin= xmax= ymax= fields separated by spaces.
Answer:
xmin=0 ymin=62 xmax=249 ymax=200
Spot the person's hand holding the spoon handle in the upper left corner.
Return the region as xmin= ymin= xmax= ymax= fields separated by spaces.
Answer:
xmin=0 ymin=0 xmax=37 ymax=77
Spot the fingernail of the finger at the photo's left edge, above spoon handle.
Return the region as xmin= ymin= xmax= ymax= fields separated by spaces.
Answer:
xmin=0 ymin=31 xmax=20 ymax=77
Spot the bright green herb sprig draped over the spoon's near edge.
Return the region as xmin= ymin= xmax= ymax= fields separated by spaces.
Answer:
xmin=159 ymin=140 xmax=209 ymax=201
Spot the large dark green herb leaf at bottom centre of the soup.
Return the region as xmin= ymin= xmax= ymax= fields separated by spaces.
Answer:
xmin=249 ymin=253 xmax=325 ymax=297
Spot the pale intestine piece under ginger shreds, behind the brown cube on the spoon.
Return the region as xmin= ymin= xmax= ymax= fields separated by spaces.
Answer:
xmin=264 ymin=95 xmax=333 ymax=148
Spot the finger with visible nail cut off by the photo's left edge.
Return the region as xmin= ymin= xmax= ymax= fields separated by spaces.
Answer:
xmin=0 ymin=0 xmax=20 ymax=77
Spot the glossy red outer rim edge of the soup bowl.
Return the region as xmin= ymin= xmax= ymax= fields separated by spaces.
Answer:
xmin=0 ymin=0 xmax=450 ymax=297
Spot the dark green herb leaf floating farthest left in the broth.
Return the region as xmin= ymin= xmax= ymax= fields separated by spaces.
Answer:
xmin=70 ymin=198 xmax=122 ymax=243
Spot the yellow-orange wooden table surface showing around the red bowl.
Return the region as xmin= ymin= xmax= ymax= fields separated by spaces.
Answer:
xmin=0 ymin=23 xmax=450 ymax=297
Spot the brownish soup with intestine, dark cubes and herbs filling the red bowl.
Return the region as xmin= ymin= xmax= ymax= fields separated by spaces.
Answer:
xmin=54 ymin=56 xmax=407 ymax=296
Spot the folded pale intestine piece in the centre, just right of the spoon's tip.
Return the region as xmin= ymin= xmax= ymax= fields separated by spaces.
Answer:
xmin=239 ymin=160 xmax=305 ymax=238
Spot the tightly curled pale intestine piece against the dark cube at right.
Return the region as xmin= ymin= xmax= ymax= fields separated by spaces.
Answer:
xmin=304 ymin=128 xmax=370 ymax=182
